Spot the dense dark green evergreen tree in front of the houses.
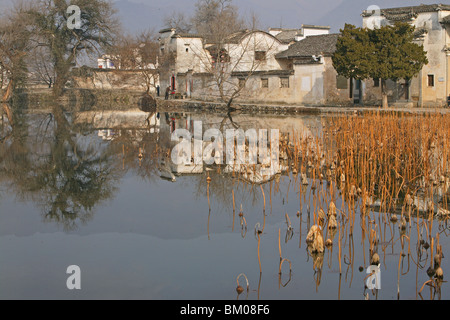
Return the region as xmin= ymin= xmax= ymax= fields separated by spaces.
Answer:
xmin=333 ymin=23 xmax=428 ymax=108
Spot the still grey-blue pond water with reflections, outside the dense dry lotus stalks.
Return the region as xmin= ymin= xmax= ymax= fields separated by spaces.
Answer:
xmin=0 ymin=111 xmax=450 ymax=300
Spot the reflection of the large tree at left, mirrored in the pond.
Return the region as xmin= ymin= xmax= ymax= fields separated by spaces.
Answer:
xmin=39 ymin=108 xmax=118 ymax=230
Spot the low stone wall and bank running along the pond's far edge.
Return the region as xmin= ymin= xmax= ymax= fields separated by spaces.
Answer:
xmin=4 ymin=89 xmax=450 ymax=114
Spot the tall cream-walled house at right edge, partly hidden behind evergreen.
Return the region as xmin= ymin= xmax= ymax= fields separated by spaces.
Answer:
xmin=362 ymin=4 xmax=450 ymax=107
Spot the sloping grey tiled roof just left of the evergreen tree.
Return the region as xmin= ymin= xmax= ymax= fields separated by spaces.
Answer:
xmin=276 ymin=33 xmax=339 ymax=59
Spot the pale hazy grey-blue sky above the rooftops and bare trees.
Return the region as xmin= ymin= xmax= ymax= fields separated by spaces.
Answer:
xmin=0 ymin=0 xmax=450 ymax=33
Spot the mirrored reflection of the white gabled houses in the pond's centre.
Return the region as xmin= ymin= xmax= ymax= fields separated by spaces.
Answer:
xmin=164 ymin=113 xmax=310 ymax=184
